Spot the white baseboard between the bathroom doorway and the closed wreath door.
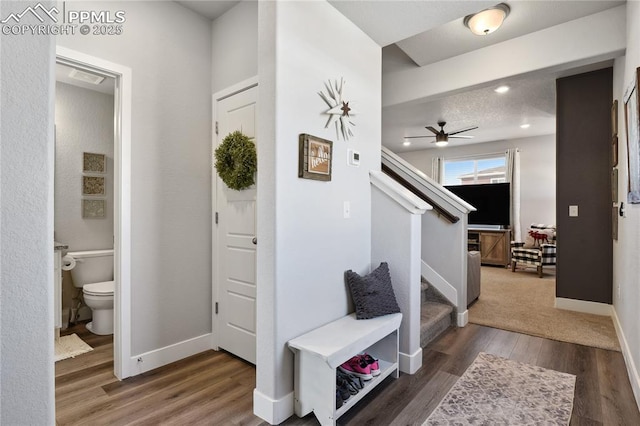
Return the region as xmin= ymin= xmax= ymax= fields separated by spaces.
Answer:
xmin=129 ymin=333 xmax=211 ymax=376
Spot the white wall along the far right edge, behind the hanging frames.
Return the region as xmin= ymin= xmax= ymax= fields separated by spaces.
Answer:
xmin=613 ymin=1 xmax=640 ymax=404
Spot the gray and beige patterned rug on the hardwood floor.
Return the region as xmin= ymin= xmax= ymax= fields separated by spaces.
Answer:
xmin=423 ymin=352 xmax=576 ymax=426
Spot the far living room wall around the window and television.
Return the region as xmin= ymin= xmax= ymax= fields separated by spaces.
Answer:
xmin=398 ymin=135 xmax=556 ymax=235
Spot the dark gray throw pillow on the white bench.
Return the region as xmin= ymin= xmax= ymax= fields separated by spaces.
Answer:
xmin=345 ymin=262 xmax=400 ymax=319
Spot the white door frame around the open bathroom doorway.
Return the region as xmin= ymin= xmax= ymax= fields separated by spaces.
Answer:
xmin=51 ymin=46 xmax=132 ymax=380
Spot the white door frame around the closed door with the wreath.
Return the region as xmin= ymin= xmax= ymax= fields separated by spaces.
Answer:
xmin=211 ymin=76 xmax=259 ymax=350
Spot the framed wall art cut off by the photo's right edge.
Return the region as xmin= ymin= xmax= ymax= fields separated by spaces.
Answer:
xmin=624 ymin=68 xmax=640 ymax=204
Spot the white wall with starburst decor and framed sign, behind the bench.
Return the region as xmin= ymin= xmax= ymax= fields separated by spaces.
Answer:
xmin=254 ymin=2 xmax=381 ymax=423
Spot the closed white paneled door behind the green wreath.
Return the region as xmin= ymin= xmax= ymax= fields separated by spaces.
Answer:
xmin=214 ymin=87 xmax=258 ymax=364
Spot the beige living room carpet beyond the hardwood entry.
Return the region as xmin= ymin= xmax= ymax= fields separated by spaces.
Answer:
xmin=469 ymin=266 xmax=620 ymax=351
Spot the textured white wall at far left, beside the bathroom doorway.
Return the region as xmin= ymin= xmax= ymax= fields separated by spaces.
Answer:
xmin=0 ymin=1 xmax=55 ymax=425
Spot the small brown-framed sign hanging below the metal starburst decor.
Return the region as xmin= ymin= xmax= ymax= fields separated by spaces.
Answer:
xmin=298 ymin=133 xmax=333 ymax=181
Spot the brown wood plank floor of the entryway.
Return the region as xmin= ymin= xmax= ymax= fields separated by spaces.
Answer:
xmin=56 ymin=324 xmax=640 ymax=426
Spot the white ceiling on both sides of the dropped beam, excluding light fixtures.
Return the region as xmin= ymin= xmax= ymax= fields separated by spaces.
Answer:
xmin=382 ymin=0 xmax=624 ymax=152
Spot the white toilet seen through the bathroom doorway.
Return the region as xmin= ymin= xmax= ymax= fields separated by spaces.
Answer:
xmin=67 ymin=249 xmax=115 ymax=335
